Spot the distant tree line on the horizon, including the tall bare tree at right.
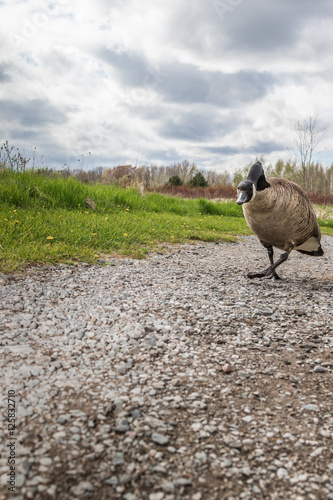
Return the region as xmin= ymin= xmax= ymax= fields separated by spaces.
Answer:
xmin=0 ymin=111 xmax=333 ymax=199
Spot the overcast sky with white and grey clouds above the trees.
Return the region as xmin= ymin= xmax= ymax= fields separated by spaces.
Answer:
xmin=0 ymin=0 xmax=333 ymax=172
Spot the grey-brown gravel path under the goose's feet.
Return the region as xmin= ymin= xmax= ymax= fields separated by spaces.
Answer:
xmin=0 ymin=236 xmax=333 ymax=500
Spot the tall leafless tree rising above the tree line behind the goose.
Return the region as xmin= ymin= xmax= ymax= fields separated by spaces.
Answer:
xmin=294 ymin=114 xmax=326 ymax=190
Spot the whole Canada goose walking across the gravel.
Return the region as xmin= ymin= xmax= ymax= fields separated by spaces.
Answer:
xmin=236 ymin=162 xmax=324 ymax=279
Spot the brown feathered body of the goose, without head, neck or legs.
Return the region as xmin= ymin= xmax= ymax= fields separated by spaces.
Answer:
xmin=243 ymin=178 xmax=321 ymax=254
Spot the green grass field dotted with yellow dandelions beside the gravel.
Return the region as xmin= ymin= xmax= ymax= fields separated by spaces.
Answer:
xmin=0 ymin=171 xmax=333 ymax=272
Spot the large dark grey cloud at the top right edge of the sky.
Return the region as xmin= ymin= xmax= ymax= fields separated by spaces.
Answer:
xmin=167 ymin=0 xmax=333 ymax=55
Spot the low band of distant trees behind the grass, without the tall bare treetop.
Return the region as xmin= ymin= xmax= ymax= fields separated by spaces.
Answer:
xmin=0 ymin=145 xmax=333 ymax=194
